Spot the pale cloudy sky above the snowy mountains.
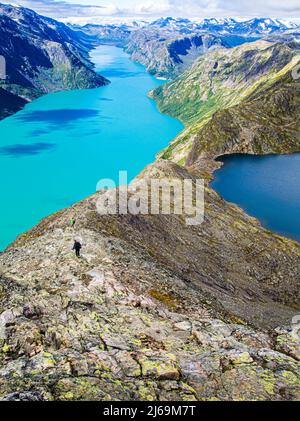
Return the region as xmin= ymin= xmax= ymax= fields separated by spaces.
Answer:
xmin=0 ymin=0 xmax=300 ymax=22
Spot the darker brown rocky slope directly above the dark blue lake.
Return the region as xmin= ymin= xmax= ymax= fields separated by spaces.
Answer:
xmin=187 ymin=68 xmax=300 ymax=165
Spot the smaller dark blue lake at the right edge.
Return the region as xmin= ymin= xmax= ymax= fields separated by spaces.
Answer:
xmin=212 ymin=154 xmax=300 ymax=241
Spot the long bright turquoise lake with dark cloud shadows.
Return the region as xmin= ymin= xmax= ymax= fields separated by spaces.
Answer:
xmin=0 ymin=46 xmax=183 ymax=250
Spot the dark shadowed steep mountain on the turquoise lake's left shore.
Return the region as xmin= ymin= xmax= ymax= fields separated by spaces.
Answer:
xmin=0 ymin=5 xmax=108 ymax=117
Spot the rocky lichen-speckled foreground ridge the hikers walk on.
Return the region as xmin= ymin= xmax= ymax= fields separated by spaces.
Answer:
xmin=0 ymin=161 xmax=300 ymax=400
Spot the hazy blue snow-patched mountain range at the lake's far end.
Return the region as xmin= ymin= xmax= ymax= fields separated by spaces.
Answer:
xmin=74 ymin=17 xmax=300 ymax=79
